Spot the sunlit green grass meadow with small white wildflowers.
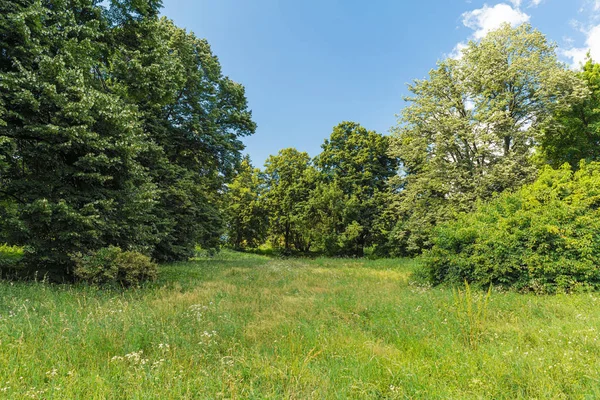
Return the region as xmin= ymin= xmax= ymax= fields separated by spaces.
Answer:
xmin=0 ymin=252 xmax=600 ymax=399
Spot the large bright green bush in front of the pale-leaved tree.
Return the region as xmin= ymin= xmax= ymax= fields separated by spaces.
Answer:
xmin=424 ymin=162 xmax=600 ymax=293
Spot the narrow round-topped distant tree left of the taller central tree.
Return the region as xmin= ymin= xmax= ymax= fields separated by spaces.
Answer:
xmin=264 ymin=148 xmax=314 ymax=252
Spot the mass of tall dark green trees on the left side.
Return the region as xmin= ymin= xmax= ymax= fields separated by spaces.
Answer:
xmin=0 ymin=0 xmax=255 ymax=276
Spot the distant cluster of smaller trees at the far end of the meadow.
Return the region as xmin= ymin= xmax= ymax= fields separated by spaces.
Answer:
xmin=228 ymin=122 xmax=398 ymax=256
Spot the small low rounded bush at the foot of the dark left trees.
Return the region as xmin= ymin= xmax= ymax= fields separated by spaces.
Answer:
xmin=73 ymin=246 xmax=158 ymax=286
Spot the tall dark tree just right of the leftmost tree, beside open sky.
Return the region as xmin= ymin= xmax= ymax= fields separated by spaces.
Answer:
xmin=107 ymin=9 xmax=256 ymax=261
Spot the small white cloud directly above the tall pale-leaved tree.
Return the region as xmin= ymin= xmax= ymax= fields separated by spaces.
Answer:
xmin=462 ymin=0 xmax=532 ymax=39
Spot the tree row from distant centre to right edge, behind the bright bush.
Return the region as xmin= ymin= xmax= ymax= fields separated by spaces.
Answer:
xmin=228 ymin=25 xmax=600 ymax=274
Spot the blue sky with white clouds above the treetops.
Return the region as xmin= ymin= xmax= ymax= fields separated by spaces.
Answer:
xmin=163 ymin=0 xmax=600 ymax=166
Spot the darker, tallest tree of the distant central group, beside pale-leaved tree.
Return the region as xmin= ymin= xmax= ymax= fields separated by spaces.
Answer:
xmin=315 ymin=122 xmax=398 ymax=256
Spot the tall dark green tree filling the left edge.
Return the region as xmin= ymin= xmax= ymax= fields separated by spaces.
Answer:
xmin=0 ymin=0 xmax=156 ymax=276
